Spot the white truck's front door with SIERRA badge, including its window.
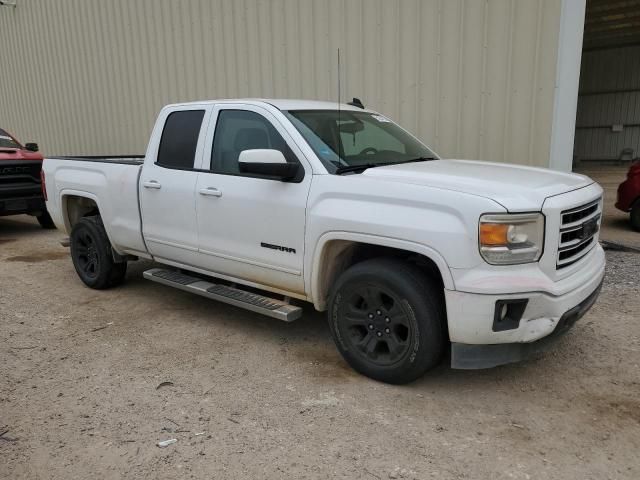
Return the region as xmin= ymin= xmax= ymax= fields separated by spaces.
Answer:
xmin=196 ymin=104 xmax=312 ymax=293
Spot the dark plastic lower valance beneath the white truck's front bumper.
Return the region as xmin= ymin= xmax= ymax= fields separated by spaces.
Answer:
xmin=451 ymin=283 xmax=602 ymax=370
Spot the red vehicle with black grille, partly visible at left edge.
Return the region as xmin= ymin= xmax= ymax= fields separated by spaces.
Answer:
xmin=0 ymin=128 xmax=55 ymax=228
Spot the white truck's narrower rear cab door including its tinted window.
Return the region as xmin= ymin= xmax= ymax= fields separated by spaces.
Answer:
xmin=139 ymin=105 xmax=212 ymax=265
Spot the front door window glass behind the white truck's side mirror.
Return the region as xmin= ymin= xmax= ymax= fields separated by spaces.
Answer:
xmin=211 ymin=110 xmax=297 ymax=175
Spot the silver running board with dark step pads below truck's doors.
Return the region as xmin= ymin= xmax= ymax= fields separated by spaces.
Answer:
xmin=143 ymin=268 xmax=302 ymax=322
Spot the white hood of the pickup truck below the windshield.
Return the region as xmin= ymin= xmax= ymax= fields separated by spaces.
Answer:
xmin=362 ymin=160 xmax=593 ymax=211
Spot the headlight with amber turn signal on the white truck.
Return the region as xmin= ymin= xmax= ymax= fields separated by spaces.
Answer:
xmin=478 ymin=213 xmax=544 ymax=265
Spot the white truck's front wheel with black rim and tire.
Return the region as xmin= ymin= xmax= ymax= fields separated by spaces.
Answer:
xmin=328 ymin=258 xmax=446 ymax=384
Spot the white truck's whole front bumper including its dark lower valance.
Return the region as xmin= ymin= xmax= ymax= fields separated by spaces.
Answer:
xmin=445 ymin=245 xmax=605 ymax=368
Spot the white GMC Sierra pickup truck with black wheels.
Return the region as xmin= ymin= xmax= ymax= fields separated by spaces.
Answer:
xmin=44 ymin=100 xmax=605 ymax=383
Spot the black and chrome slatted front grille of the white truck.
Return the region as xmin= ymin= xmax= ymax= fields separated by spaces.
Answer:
xmin=556 ymin=198 xmax=602 ymax=270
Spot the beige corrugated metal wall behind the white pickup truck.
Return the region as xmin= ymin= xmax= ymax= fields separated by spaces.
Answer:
xmin=0 ymin=0 xmax=561 ymax=166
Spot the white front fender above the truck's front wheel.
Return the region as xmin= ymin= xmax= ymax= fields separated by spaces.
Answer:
xmin=304 ymin=175 xmax=505 ymax=308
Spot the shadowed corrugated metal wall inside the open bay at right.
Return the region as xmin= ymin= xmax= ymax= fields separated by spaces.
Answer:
xmin=574 ymin=46 xmax=640 ymax=160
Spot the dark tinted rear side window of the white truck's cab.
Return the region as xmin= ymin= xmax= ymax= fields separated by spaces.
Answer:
xmin=157 ymin=110 xmax=204 ymax=168
